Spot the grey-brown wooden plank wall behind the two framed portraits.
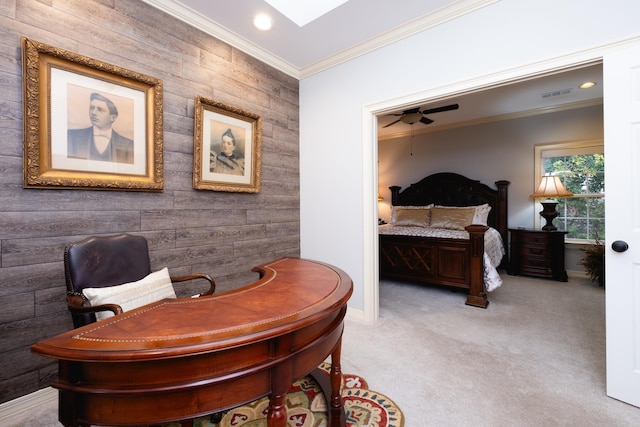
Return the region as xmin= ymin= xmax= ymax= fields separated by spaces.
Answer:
xmin=0 ymin=0 xmax=300 ymax=402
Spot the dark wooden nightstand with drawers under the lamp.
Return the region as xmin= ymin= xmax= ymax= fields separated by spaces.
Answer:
xmin=509 ymin=228 xmax=567 ymax=282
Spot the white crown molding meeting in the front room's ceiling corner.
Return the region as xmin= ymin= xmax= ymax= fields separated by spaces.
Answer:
xmin=142 ymin=0 xmax=500 ymax=80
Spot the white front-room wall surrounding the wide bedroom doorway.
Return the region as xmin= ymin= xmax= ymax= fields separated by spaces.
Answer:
xmin=300 ymin=0 xmax=640 ymax=318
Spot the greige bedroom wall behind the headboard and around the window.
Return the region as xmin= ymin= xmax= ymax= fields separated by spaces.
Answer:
xmin=378 ymin=105 xmax=604 ymax=228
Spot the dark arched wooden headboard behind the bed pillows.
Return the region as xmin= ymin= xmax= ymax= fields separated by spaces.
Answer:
xmin=389 ymin=172 xmax=510 ymax=244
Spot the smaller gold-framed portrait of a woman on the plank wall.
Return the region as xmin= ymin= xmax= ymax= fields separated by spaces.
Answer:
xmin=193 ymin=97 xmax=262 ymax=193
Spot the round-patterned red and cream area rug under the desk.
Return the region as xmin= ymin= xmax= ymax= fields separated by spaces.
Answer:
xmin=167 ymin=363 xmax=404 ymax=427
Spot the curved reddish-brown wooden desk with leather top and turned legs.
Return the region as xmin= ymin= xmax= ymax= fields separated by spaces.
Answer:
xmin=31 ymin=258 xmax=352 ymax=426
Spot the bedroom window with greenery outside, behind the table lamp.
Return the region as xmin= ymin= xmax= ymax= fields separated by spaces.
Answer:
xmin=535 ymin=140 xmax=605 ymax=241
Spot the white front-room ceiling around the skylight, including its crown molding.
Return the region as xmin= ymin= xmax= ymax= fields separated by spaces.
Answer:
xmin=144 ymin=0 xmax=476 ymax=78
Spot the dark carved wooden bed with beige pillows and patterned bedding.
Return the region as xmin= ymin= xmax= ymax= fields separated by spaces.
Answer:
xmin=378 ymin=172 xmax=509 ymax=308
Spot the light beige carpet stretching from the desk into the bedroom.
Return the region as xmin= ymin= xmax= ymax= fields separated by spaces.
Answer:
xmin=342 ymin=273 xmax=640 ymax=427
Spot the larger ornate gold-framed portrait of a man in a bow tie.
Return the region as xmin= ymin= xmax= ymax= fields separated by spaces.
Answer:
xmin=22 ymin=38 xmax=164 ymax=191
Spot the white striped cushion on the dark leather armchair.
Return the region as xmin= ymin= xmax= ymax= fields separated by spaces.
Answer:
xmin=83 ymin=267 xmax=176 ymax=320
